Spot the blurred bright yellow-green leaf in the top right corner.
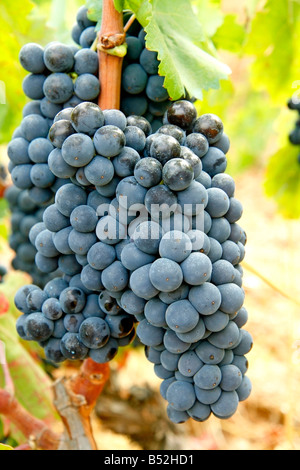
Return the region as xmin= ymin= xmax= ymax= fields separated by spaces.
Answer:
xmin=245 ymin=0 xmax=300 ymax=103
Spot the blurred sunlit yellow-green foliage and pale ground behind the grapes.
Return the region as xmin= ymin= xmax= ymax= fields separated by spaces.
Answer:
xmin=0 ymin=0 xmax=300 ymax=450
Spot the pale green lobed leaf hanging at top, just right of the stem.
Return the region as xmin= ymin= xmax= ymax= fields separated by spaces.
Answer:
xmin=145 ymin=0 xmax=231 ymax=100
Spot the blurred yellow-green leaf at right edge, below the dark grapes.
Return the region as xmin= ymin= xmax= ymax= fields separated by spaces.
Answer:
xmin=264 ymin=144 xmax=300 ymax=219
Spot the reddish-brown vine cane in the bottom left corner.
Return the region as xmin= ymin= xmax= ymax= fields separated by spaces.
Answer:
xmin=0 ymin=390 xmax=60 ymax=450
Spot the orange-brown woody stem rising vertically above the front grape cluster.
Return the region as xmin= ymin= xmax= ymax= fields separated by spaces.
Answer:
xmin=98 ymin=0 xmax=125 ymax=109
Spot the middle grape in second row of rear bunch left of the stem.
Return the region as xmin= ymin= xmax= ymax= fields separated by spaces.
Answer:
xmin=43 ymin=73 xmax=74 ymax=104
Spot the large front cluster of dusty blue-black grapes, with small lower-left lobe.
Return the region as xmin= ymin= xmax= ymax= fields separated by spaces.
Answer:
xmin=16 ymin=100 xmax=252 ymax=423
